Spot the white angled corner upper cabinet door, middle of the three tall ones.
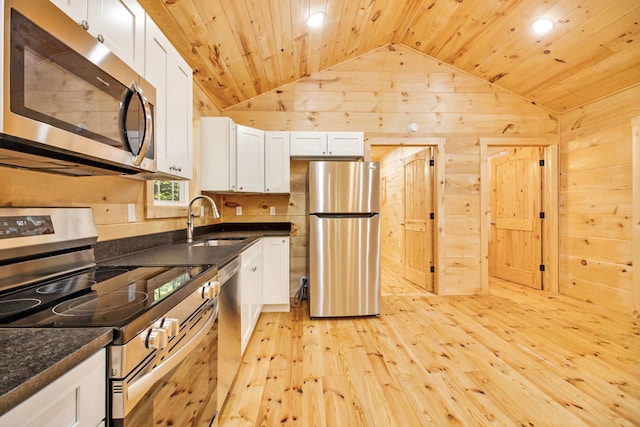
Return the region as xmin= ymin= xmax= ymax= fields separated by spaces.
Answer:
xmin=236 ymin=125 xmax=264 ymax=193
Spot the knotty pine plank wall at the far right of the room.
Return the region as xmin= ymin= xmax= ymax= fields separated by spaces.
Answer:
xmin=559 ymin=87 xmax=640 ymax=313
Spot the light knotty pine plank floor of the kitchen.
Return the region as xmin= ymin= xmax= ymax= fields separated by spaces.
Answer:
xmin=219 ymin=267 xmax=640 ymax=427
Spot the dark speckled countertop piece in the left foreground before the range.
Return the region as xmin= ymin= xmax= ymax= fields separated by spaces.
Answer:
xmin=0 ymin=328 xmax=113 ymax=415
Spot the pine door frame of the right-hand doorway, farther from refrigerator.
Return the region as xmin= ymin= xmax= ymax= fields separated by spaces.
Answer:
xmin=480 ymin=138 xmax=559 ymax=294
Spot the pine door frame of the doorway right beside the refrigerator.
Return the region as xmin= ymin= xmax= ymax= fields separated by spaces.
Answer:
xmin=365 ymin=137 xmax=446 ymax=295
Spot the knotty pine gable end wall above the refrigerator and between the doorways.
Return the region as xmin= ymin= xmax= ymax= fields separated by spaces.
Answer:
xmin=221 ymin=45 xmax=557 ymax=294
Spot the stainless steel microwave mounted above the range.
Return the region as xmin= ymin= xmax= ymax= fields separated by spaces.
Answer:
xmin=0 ymin=0 xmax=156 ymax=178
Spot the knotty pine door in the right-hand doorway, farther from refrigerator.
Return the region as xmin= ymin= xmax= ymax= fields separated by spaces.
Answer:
xmin=489 ymin=147 xmax=542 ymax=289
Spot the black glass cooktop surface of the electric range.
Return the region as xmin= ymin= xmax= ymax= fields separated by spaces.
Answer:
xmin=0 ymin=266 xmax=210 ymax=327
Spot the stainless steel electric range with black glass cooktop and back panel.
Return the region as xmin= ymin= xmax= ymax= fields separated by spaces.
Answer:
xmin=0 ymin=207 xmax=220 ymax=426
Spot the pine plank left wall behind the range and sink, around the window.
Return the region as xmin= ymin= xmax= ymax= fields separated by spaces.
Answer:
xmin=0 ymin=84 xmax=220 ymax=241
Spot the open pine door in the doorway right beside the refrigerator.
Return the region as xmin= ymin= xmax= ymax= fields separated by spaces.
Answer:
xmin=402 ymin=148 xmax=433 ymax=292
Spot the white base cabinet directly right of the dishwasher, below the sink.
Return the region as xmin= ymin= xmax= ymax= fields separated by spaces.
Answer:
xmin=238 ymin=239 xmax=262 ymax=354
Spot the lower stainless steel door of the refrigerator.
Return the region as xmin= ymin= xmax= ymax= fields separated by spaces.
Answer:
xmin=309 ymin=214 xmax=380 ymax=317
